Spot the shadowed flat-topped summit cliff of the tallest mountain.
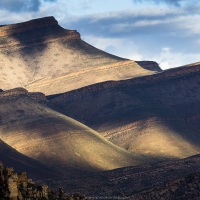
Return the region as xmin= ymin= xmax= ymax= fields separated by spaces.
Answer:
xmin=0 ymin=17 xmax=80 ymax=48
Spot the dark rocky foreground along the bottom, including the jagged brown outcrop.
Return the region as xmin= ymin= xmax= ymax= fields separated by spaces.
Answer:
xmin=0 ymin=155 xmax=200 ymax=200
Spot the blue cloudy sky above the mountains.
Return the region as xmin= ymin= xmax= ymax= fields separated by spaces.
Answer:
xmin=0 ymin=0 xmax=200 ymax=69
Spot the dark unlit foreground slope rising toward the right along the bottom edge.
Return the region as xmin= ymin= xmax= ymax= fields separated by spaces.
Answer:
xmin=47 ymin=155 xmax=200 ymax=199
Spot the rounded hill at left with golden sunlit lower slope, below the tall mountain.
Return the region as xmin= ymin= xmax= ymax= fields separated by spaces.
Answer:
xmin=0 ymin=88 xmax=151 ymax=172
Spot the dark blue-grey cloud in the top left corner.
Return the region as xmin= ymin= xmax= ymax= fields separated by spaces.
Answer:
xmin=0 ymin=0 xmax=41 ymax=12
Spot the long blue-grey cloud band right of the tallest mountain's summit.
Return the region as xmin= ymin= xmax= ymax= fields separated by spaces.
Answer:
xmin=67 ymin=12 xmax=180 ymax=37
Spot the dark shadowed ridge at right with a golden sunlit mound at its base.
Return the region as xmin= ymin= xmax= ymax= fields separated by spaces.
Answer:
xmin=48 ymin=63 xmax=200 ymax=159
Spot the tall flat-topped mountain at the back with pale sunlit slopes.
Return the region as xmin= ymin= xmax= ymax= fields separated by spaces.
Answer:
xmin=0 ymin=17 xmax=158 ymax=95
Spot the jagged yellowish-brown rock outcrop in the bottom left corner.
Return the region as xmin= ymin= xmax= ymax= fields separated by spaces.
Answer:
xmin=0 ymin=162 xmax=86 ymax=200
